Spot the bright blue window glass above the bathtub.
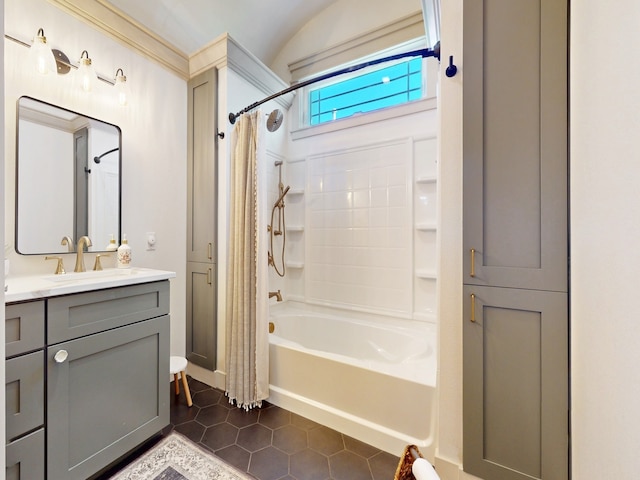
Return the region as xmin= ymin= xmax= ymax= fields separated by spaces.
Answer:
xmin=309 ymin=58 xmax=422 ymax=125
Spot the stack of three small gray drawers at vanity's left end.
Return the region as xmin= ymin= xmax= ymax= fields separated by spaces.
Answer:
xmin=5 ymin=301 xmax=45 ymax=480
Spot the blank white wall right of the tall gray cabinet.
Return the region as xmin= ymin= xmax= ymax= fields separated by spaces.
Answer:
xmin=570 ymin=0 xmax=640 ymax=479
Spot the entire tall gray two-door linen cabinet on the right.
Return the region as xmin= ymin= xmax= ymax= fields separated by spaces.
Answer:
xmin=462 ymin=0 xmax=569 ymax=480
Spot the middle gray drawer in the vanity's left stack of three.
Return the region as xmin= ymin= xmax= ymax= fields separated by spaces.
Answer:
xmin=5 ymin=350 xmax=44 ymax=441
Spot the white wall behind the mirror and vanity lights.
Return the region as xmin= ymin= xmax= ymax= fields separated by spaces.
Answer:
xmin=4 ymin=0 xmax=187 ymax=354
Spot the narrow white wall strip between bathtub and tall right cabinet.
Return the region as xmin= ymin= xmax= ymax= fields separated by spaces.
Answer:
xmin=436 ymin=0 xmax=464 ymax=480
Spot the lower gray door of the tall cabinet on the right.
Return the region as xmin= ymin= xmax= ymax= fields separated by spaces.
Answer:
xmin=463 ymin=286 xmax=569 ymax=480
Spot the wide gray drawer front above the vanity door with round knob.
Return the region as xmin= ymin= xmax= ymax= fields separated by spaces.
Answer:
xmin=47 ymin=280 xmax=169 ymax=345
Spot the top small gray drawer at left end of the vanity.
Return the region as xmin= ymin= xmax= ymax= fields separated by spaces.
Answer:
xmin=4 ymin=300 xmax=44 ymax=358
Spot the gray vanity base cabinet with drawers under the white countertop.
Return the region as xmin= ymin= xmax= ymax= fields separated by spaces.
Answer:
xmin=6 ymin=280 xmax=169 ymax=480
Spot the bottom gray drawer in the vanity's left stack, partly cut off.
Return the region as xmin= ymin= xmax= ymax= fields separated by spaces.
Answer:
xmin=5 ymin=428 xmax=44 ymax=480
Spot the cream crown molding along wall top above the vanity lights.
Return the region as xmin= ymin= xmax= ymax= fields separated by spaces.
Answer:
xmin=48 ymin=0 xmax=189 ymax=80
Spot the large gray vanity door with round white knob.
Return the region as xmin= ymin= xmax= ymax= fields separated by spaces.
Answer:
xmin=47 ymin=315 xmax=169 ymax=480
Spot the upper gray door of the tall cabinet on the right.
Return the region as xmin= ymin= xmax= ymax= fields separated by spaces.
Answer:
xmin=463 ymin=0 xmax=568 ymax=291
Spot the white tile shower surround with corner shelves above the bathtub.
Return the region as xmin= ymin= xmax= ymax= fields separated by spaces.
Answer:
xmin=285 ymin=138 xmax=437 ymax=318
